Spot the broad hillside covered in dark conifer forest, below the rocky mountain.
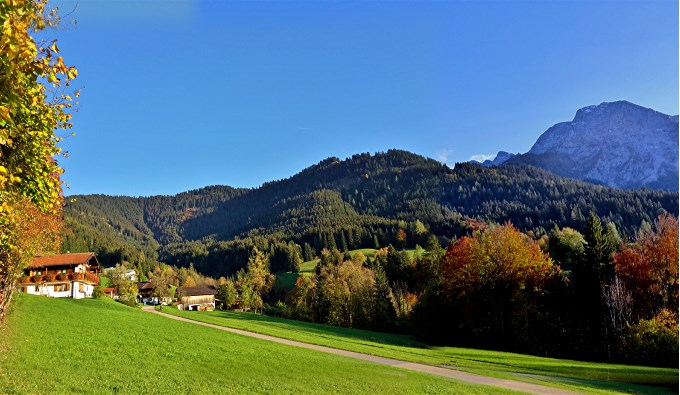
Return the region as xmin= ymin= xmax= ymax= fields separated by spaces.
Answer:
xmin=63 ymin=150 xmax=678 ymax=275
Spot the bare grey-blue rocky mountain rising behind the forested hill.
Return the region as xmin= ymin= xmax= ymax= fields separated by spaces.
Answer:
xmin=505 ymin=101 xmax=678 ymax=191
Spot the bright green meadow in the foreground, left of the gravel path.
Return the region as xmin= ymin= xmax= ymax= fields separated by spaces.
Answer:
xmin=0 ymin=294 xmax=506 ymax=394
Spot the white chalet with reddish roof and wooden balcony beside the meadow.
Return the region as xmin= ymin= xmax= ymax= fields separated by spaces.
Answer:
xmin=17 ymin=252 xmax=101 ymax=299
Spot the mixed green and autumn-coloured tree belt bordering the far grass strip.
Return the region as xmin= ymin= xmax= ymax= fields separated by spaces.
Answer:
xmin=207 ymin=214 xmax=678 ymax=366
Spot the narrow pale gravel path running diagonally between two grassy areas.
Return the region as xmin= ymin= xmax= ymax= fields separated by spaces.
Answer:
xmin=143 ymin=306 xmax=579 ymax=395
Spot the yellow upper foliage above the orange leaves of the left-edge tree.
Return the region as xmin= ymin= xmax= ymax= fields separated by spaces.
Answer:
xmin=0 ymin=0 xmax=78 ymax=214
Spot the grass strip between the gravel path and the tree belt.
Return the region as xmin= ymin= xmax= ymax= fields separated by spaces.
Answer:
xmin=164 ymin=308 xmax=678 ymax=394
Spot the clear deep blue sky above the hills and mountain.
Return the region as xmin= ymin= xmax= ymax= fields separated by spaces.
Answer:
xmin=49 ymin=0 xmax=678 ymax=196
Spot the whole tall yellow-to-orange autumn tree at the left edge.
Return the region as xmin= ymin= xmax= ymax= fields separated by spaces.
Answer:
xmin=0 ymin=0 xmax=78 ymax=319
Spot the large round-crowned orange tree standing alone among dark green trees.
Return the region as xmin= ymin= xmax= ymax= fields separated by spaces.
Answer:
xmin=441 ymin=223 xmax=560 ymax=350
